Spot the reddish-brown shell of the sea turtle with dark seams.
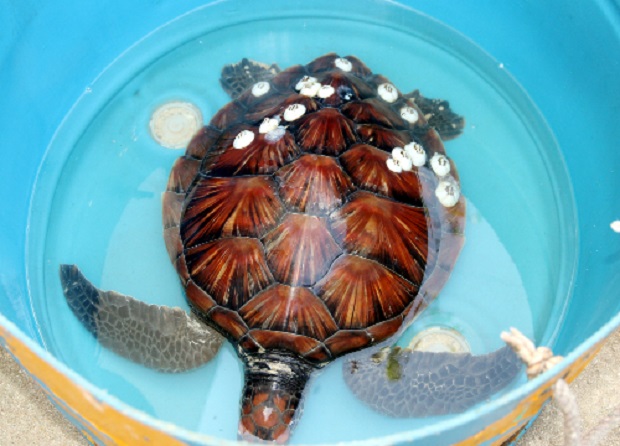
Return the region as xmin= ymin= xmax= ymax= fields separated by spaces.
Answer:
xmin=163 ymin=54 xmax=465 ymax=365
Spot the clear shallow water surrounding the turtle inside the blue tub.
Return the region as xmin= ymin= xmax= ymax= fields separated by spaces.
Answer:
xmin=28 ymin=1 xmax=576 ymax=443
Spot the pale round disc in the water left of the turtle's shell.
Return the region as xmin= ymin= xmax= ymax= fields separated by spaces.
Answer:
xmin=149 ymin=101 xmax=202 ymax=149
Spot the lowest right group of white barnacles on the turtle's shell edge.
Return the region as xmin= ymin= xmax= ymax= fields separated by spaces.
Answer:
xmin=386 ymin=142 xmax=461 ymax=207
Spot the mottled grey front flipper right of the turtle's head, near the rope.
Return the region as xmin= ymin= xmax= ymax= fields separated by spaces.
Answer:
xmin=344 ymin=347 xmax=522 ymax=418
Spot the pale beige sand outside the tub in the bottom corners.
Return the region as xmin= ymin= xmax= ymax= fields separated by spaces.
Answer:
xmin=0 ymin=331 xmax=620 ymax=446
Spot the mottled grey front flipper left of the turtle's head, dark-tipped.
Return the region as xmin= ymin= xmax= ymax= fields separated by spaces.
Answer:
xmin=60 ymin=265 xmax=223 ymax=373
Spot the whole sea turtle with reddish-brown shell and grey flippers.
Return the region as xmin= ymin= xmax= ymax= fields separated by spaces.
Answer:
xmin=60 ymin=54 xmax=513 ymax=442
